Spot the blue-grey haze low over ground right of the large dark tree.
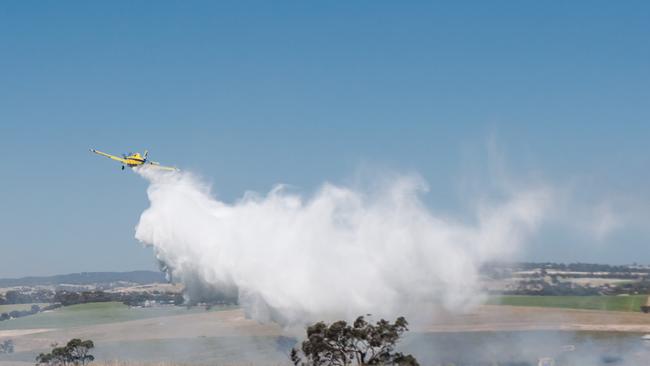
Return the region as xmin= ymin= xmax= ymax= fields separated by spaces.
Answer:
xmin=401 ymin=331 xmax=650 ymax=366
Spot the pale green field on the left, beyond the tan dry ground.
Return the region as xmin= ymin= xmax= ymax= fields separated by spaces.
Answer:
xmin=0 ymin=302 xmax=233 ymax=330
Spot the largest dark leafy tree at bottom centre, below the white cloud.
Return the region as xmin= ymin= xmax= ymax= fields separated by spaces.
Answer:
xmin=291 ymin=316 xmax=418 ymax=366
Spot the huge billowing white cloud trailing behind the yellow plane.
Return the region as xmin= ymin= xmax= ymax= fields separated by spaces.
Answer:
xmin=136 ymin=169 xmax=551 ymax=325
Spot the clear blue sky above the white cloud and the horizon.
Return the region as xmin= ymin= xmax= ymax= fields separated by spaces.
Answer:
xmin=0 ymin=1 xmax=650 ymax=277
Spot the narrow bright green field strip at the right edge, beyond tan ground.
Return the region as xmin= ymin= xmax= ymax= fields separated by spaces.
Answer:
xmin=488 ymin=295 xmax=648 ymax=311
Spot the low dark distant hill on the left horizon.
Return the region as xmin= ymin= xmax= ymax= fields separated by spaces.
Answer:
xmin=0 ymin=271 xmax=167 ymax=288
